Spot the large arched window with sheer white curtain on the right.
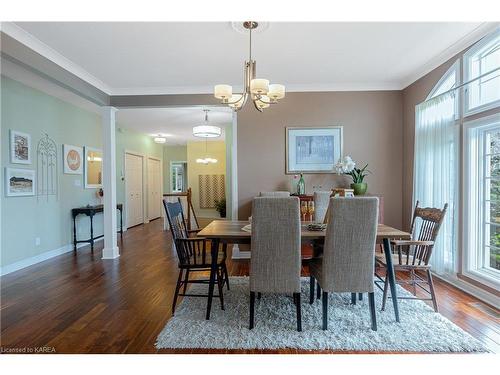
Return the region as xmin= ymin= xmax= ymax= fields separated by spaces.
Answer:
xmin=413 ymin=29 xmax=500 ymax=289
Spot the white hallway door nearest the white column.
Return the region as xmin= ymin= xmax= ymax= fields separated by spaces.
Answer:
xmin=125 ymin=154 xmax=144 ymax=228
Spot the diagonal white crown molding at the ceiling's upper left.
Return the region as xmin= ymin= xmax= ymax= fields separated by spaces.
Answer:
xmin=1 ymin=22 xmax=112 ymax=95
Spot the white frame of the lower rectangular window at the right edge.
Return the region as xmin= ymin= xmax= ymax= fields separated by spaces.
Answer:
xmin=462 ymin=113 xmax=500 ymax=289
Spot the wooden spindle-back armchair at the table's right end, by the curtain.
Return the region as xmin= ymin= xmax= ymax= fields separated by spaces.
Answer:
xmin=375 ymin=201 xmax=448 ymax=312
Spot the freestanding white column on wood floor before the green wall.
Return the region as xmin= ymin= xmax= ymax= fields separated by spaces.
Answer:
xmin=101 ymin=106 xmax=120 ymax=259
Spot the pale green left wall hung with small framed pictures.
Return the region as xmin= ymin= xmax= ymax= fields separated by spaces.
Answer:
xmin=0 ymin=76 xmax=163 ymax=267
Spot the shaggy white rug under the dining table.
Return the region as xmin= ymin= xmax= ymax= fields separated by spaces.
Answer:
xmin=156 ymin=277 xmax=487 ymax=352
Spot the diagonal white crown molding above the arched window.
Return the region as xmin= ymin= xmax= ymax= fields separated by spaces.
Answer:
xmin=399 ymin=22 xmax=500 ymax=90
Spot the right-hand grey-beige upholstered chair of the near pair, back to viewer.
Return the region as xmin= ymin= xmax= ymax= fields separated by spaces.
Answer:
xmin=309 ymin=197 xmax=378 ymax=331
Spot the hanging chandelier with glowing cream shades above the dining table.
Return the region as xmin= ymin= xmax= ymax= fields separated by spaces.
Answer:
xmin=214 ymin=21 xmax=285 ymax=112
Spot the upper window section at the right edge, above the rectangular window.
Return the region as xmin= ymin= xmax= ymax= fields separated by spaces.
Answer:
xmin=464 ymin=30 xmax=500 ymax=115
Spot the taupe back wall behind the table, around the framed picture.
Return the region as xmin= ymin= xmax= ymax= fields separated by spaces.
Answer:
xmin=238 ymin=91 xmax=403 ymax=227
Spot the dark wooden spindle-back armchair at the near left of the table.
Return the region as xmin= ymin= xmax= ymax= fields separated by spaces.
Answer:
xmin=163 ymin=199 xmax=229 ymax=315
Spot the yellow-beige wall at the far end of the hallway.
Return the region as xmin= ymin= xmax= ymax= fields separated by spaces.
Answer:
xmin=187 ymin=141 xmax=227 ymax=217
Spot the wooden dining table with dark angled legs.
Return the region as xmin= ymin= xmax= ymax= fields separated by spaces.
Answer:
xmin=198 ymin=220 xmax=411 ymax=322
